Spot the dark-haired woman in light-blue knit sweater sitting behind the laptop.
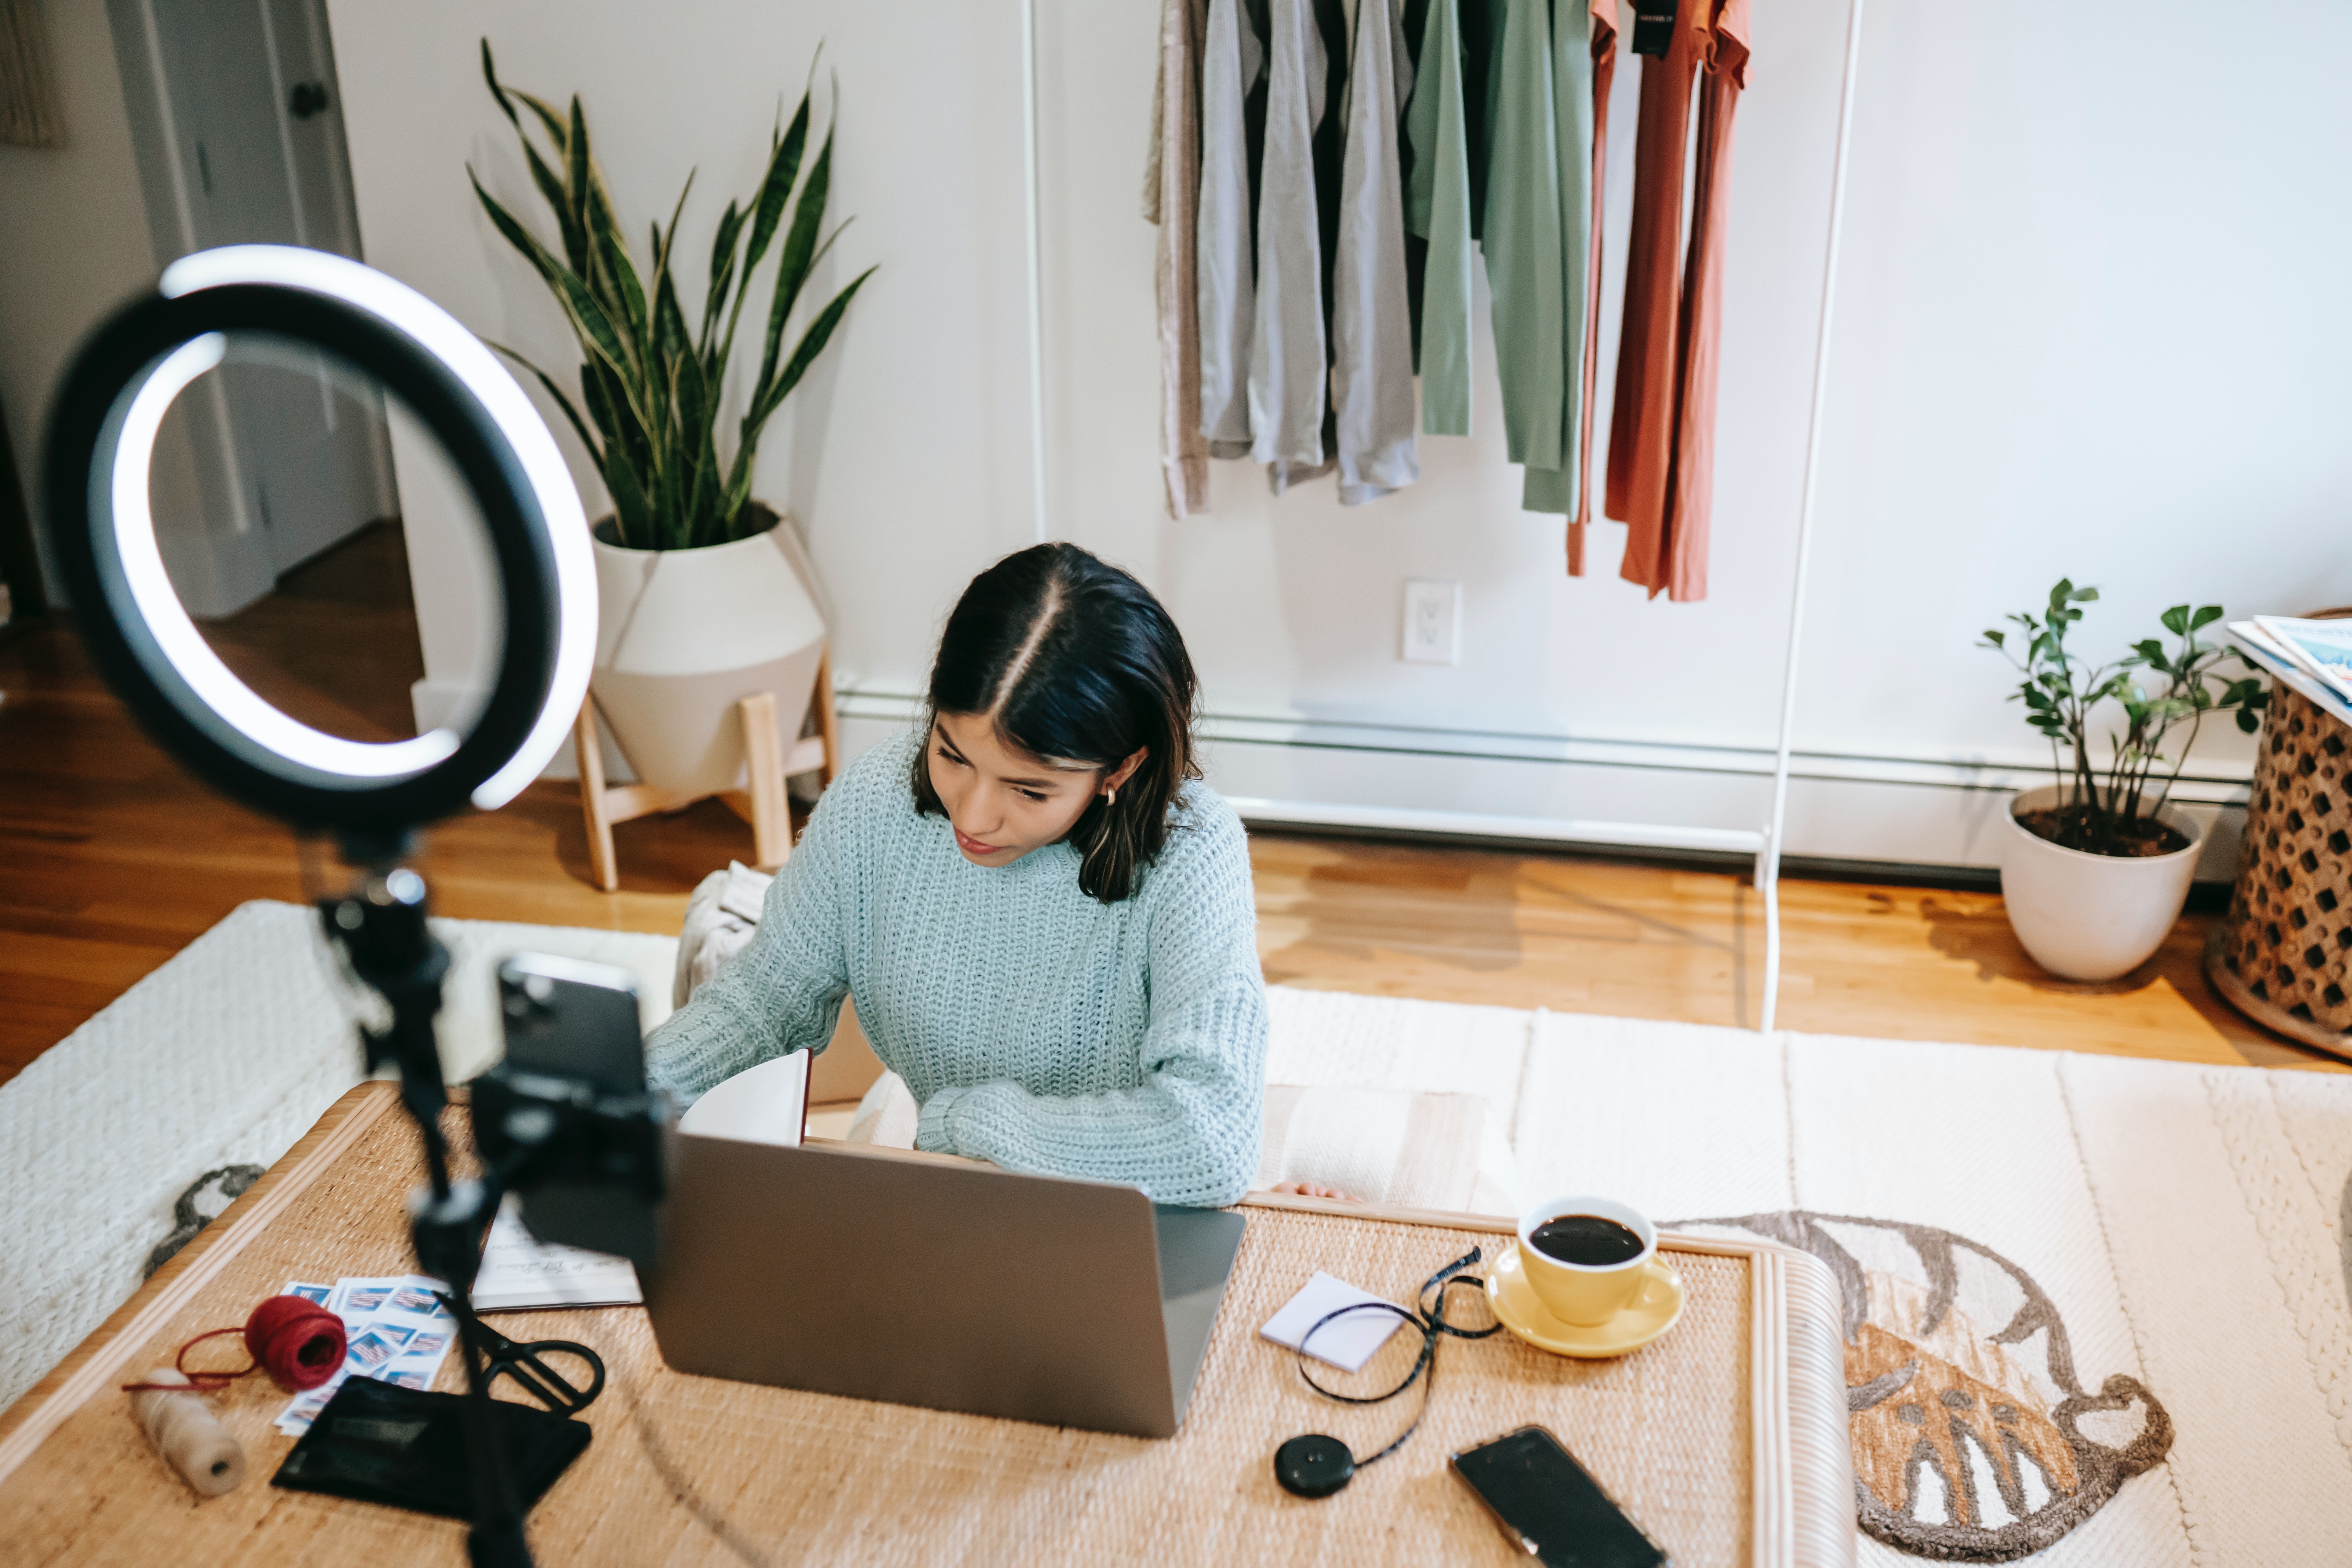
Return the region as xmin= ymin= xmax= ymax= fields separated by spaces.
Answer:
xmin=647 ymin=545 xmax=1265 ymax=1206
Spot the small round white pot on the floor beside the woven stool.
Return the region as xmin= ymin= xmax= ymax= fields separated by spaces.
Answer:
xmin=2002 ymin=785 xmax=2204 ymax=980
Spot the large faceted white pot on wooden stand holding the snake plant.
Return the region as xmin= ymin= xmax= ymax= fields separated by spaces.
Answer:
xmin=588 ymin=522 xmax=826 ymax=797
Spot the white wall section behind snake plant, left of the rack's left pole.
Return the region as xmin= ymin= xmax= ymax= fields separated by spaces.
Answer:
xmin=329 ymin=0 xmax=1030 ymax=762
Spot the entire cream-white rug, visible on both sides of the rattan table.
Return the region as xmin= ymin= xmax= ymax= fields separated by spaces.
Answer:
xmin=0 ymin=905 xmax=2352 ymax=1568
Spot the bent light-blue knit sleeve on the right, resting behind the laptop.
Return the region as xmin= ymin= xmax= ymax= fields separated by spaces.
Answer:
xmin=915 ymin=811 xmax=1265 ymax=1208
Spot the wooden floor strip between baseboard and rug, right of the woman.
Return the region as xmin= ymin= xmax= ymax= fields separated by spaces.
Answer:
xmin=1251 ymin=835 xmax=2324 ymax=1072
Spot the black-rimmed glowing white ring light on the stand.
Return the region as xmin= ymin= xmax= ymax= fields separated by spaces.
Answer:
xmin=47 ymin=245 xmax=597 ymax=832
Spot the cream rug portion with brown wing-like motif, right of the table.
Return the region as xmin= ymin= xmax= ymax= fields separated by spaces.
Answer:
xmin=1268 ymin=990 xmax=2352 ymax=1568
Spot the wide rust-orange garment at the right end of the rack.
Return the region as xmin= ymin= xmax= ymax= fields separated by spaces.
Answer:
xmin=1604 ymin=0 xmax=1750 ymax=599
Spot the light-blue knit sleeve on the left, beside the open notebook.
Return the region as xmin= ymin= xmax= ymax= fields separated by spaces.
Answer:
xmin=644 ymin=790 xmax=858 ymax=1105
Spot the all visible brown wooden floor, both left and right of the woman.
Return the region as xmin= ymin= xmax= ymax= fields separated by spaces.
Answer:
xmin=0 ymin=606 xmax=2347 ymax=1079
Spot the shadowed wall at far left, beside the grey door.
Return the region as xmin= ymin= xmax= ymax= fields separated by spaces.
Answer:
xmin=0 ymin=0 xmax=155 ymax=599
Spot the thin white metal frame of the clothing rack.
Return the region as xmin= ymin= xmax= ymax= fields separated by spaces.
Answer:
xmin=1021 ymin=0 xmax=1863 ymax=1034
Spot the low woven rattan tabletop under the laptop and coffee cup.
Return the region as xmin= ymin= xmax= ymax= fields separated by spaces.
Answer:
xmin=0 ymin=1086 xmax=1851 ymax=1568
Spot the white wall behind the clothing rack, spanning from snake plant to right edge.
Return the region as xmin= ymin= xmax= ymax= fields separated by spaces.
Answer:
xmin=332 ymin=0 xmax=2352 ymax=870
